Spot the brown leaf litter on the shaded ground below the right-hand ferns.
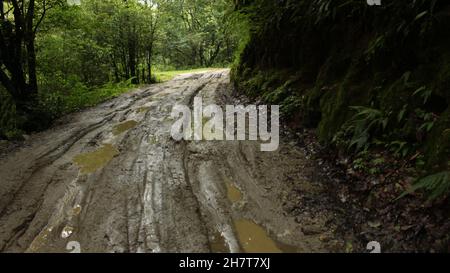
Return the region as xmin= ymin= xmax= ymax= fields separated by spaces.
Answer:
xmin=288 ymin=129 xmax=450 ymax=252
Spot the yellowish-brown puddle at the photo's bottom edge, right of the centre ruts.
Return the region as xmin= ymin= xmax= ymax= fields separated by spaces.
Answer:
xmin=234 ymin=220 xmax=282 ymax=253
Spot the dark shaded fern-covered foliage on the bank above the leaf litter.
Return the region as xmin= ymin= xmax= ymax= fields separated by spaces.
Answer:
xmin=233 ymin=0 xmax=450 ymax=196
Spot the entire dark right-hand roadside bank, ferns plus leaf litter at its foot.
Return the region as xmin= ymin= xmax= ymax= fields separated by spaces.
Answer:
xmin=232 ymin=0 xmax=450 ymax=251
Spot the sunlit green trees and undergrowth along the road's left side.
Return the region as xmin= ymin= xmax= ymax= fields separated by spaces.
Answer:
xmin=0 ymin=0 xmax=237 ymax=138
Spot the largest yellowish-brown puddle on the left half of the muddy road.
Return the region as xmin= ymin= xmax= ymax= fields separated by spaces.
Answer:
xmin=73 ymin=144 xmax=119 ymax=174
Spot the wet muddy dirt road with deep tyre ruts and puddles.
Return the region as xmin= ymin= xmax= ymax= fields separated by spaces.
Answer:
xmin=0 ymin=70 xmax=338 ymax=252
